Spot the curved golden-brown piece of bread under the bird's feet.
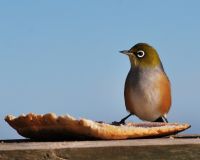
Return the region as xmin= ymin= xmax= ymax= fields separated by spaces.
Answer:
xmin=5 ymin=113 xmax=190 ymax=140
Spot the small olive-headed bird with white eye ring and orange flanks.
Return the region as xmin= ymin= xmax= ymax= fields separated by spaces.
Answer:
xmin=120 ymin=43 xmax=171 ymax=123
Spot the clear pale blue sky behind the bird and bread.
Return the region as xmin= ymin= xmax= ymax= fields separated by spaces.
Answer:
xmin=0 ymin=0 xmax=200 ymax=139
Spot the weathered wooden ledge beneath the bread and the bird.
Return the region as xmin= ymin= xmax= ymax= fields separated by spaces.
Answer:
xmin=0 ymin=135 xmax=200 ymax=160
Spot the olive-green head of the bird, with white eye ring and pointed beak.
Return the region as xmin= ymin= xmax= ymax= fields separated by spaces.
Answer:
xmin=120 ymin=43 xmax=162 ymax=68
